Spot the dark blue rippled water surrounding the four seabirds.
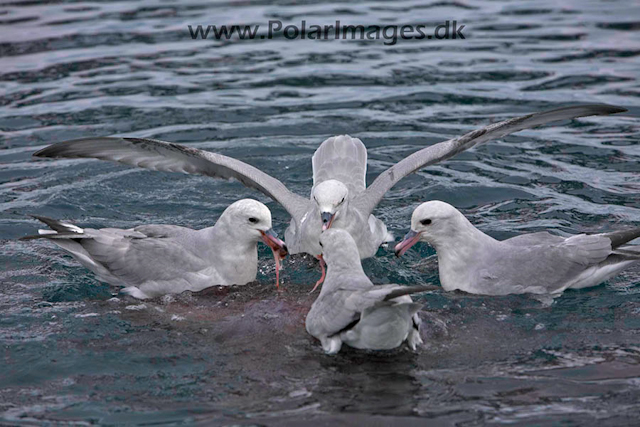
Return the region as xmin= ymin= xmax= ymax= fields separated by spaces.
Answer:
xmin=0 ymin=0 xmax=640 ymax=426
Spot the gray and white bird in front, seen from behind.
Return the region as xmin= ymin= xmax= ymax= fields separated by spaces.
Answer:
xmin=306 ymin=229 xmax=437 ymax=354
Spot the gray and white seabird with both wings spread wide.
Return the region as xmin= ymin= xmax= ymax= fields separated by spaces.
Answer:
xmin=34 ymin=104 xmax=626 ymax=258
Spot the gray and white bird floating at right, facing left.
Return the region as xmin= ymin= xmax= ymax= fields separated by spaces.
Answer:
xmin=395 ymin=200 xmax=640 ymax=295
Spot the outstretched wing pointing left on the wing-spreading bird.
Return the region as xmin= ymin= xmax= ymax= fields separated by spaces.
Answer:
xmin=34 ymin=138 xmax=310 ymax=219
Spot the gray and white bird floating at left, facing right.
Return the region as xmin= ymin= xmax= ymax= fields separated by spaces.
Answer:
xmin=22 ymin=199 xmax=287 ymax=299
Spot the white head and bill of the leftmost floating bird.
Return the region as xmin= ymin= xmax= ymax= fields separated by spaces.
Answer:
xmin=220 ymin=199 xmax=287 ymax=256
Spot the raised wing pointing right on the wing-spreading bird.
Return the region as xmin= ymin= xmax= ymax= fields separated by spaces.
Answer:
xmin=358 ymin=104 xmax=627 ymax=213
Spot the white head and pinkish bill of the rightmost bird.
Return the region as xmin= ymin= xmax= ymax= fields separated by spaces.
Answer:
xmin=395 ymin=200 xmax=470 ymax=256
